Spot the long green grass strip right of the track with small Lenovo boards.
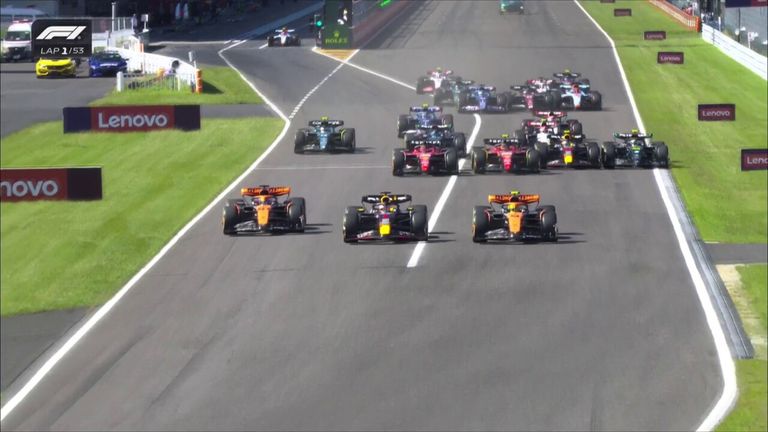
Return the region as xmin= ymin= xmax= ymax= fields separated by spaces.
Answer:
xmin=581 ymin=0 xmax=768 ymax=243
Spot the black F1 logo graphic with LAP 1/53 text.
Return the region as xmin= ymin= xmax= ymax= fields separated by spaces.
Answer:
xmin=32 ymin=19 xmax=93 ymax=58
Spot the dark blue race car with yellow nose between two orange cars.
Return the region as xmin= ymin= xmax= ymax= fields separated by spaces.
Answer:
xmin=342 ymin=192 xmax=429 ymax=243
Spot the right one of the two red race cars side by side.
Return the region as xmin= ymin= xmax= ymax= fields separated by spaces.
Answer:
xmin=472 ymin=134 xmax=541 ymax=174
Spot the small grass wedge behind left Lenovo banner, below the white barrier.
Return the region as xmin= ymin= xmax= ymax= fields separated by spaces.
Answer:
xmin=91 ymin=66 xmax=264 ymax=106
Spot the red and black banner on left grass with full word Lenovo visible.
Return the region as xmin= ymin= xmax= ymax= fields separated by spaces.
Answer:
xmin=64 ymin=105 xmax=200 ymax=133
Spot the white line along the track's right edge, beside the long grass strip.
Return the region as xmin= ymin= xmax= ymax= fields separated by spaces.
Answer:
xmin=573 ymin=0 xmax=738 ymax=431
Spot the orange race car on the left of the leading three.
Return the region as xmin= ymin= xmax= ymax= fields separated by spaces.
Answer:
xmin=221 ymin=185 xmax=307 ymax=235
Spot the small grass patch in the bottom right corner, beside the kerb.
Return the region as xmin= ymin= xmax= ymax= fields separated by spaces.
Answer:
xmin=717 ymin=264 xmax=768 ymax=432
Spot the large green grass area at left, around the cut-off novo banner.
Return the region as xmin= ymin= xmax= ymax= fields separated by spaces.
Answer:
xmin=0 ymin=118 xmax=283 ymax=316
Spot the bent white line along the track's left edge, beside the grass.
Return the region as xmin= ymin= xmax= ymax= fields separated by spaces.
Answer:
xmin=0 ymin=35 xmax=291 ymax=421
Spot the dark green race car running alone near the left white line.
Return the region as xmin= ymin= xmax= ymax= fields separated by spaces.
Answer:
xmin=293 ymin=117 xmax=356 ymax=154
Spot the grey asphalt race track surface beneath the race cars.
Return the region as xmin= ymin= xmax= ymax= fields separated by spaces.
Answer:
xmin=3 ymin=1 xmax=722 ymax=430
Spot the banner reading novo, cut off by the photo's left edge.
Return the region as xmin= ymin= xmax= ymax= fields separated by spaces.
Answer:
xmin=0 ymin=167 xmax=101 ymax=202
